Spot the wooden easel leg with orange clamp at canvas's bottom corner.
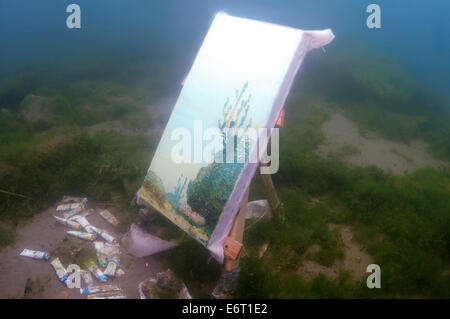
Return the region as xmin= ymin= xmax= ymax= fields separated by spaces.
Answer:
xmin=224 ymin=190 xmax=249 ymax=270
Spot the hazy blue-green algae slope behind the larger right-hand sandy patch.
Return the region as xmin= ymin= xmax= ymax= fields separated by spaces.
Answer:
xmin=298 ymin=52 xmax=450 ymax=161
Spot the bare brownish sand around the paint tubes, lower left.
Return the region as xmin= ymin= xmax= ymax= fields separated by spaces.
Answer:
xmin=0 ymin=206 xmax=165 ymax=299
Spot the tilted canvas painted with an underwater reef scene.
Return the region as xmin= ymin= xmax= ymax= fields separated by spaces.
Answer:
xmin=140 ymin=14 xmax=328 ymax=251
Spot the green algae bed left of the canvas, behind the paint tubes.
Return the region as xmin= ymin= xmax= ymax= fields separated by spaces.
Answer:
xmin=0 ymin=128 xmax=152 ymax=230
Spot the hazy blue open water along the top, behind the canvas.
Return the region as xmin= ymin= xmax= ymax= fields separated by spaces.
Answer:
xmin=0 ymin=0 xmax=450 ymax=95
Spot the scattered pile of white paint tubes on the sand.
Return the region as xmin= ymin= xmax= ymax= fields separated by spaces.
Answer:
xmin=20 ymin=196 xmax=126 ymax=299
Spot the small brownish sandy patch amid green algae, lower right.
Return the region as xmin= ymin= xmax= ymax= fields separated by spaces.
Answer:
xmin=297 ymin=224 xmax=373 ymax=281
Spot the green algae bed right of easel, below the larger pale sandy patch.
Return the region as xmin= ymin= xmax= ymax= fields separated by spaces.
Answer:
xmin=236 ymin=105 xmax=450 ymax=298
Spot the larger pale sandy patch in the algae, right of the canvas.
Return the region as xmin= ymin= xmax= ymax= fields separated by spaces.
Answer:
xmin=317 ymin=111 xmax=448 ymax=174
